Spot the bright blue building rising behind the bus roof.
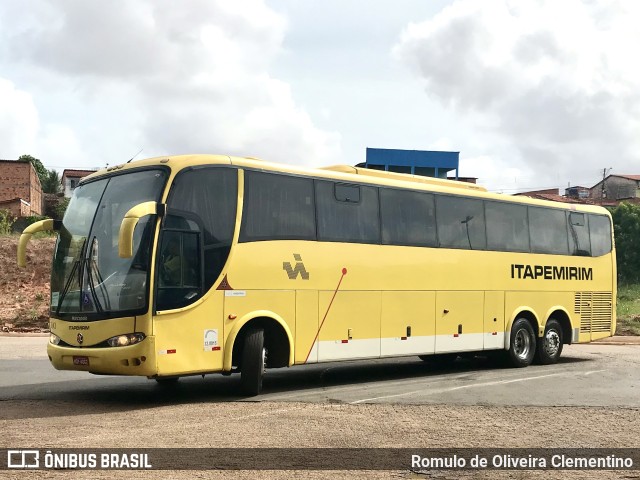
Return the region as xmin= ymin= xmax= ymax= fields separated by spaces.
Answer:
xmin=357 ymin=148 xmax=460 ymax=180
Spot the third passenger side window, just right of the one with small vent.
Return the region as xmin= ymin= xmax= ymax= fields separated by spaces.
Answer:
xmin=380 ymin=189 xmax=437 ymax=247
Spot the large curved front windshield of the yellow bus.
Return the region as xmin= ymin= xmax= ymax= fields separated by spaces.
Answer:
xmin=51 ymin=170 xmax=167 ymax=321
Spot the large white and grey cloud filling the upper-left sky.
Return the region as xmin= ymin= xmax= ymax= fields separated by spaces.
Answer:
xmin=0 ymin=0 xmax=340 ymax=166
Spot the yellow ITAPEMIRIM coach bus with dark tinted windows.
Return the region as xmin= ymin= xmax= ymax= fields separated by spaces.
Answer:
xmin=18 ymin=155 xmax=616 ymax=395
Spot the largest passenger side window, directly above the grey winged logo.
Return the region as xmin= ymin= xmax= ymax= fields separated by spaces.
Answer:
xmin=240 ymin=171 xmax=316 ymax=242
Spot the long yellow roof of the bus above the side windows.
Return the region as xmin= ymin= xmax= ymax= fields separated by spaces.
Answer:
xmin=81 ymin=154 xmax=609 ymax=215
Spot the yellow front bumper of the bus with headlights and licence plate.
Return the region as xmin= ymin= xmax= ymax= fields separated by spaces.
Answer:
xmin=47 ymin=336 xmax=157 ymax=376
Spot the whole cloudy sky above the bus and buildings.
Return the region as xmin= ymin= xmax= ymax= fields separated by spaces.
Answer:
xmin=0 ymin=0 xmax=640 ymax=193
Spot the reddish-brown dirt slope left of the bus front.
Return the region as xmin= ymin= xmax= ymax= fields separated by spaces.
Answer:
xmin=0 ymin=235 xmax=56 ymax=332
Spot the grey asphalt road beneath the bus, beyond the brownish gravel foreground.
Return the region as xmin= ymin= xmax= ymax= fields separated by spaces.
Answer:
xmin=0 ymin=337 xmax=640 ymax=407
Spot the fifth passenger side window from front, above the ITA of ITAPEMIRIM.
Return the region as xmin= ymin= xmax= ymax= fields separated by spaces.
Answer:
xmin=485 ymin=202 xmax=529 ymax=252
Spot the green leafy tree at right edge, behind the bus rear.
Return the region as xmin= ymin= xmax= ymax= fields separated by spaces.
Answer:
xmin=611 ymin=203 xmax=640 ymax=283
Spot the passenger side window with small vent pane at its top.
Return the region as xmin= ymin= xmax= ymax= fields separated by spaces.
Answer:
xmin=316 ymin=181 xmax=380 ymax=243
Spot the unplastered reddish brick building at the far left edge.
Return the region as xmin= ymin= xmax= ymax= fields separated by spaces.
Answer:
xmin=0 ymin=160 xmax=42 ymax=218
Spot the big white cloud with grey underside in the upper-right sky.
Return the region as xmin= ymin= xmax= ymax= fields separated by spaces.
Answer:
xmin=395 ymin=0 xmax=640 ymax=191
